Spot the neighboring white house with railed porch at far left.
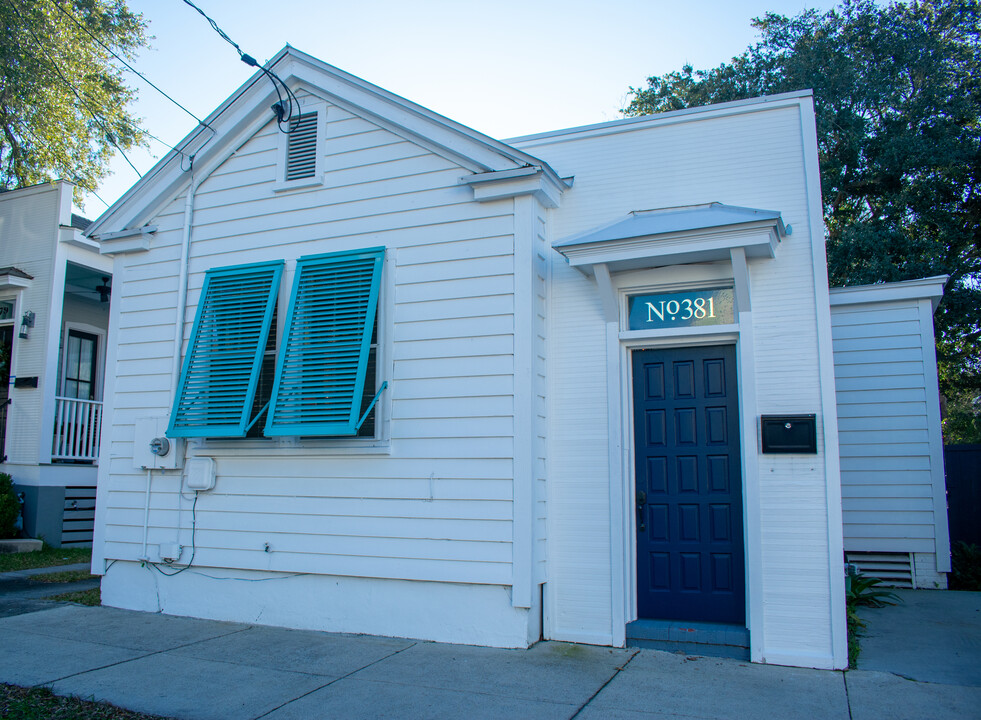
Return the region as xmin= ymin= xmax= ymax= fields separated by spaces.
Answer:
xmin=0 ymin=182 xmax=112 ymax=547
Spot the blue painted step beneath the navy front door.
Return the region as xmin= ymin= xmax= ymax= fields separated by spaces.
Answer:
xmin=627 ymin=618 xmax=749 ymax=660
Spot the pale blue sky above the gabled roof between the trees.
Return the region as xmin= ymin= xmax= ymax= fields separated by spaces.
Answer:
xmin=82 ymin=0 xmax=834 ymax=217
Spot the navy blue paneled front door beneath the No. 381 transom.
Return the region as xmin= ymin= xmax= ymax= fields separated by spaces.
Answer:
xmin=633 ymin=345 xmax=746 ymax=625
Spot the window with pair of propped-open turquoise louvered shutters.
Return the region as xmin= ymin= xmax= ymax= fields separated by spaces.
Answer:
xmin=168 ymin=248 xmax=385 ymax=437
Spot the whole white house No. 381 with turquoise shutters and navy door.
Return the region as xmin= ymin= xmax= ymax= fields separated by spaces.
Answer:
xmin=88 ymin=48 xmax=847 ymax=668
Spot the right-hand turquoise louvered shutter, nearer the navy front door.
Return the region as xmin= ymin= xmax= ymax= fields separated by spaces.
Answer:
xmin=264 ymin=248 xmax=385 ymax=436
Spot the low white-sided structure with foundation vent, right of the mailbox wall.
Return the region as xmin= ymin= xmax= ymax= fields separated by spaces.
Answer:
xmin=831 ymin=276 xmax=950 ymax=588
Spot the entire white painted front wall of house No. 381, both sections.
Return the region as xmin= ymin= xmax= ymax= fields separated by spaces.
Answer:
xmin=94 ymin=67 xmax=844 ymax=667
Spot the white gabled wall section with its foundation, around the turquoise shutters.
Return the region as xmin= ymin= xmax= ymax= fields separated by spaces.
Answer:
xmin=96 ymin=94 xmax=545 ymax=646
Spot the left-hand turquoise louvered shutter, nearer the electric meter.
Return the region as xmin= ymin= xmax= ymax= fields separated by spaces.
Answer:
xmin=167 ymin=261 xmax=283 ymax=437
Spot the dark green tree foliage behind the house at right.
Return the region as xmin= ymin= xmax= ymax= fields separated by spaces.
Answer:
xmin=624 ymin=0 xmax=981 ymax=404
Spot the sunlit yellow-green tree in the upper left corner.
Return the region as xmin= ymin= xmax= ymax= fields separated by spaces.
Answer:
xmin=0 ymin=0 xmax=147 ymax=205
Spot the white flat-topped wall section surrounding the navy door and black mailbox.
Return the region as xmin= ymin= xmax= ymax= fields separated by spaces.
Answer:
xmin=512 ymin=98 xmax=844 ymax=667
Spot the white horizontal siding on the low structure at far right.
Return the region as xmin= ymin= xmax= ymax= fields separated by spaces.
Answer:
xmin=831 ymin=299 xmax=946 ymax=553
